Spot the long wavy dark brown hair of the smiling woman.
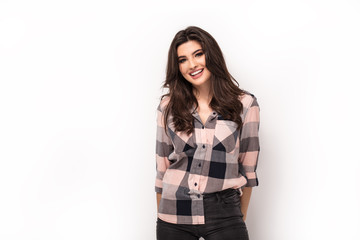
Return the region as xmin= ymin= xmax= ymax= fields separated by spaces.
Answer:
xmin=161 ymin=26 xmax=244 ymax=135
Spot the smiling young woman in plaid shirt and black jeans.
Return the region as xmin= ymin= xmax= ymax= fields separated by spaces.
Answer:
xmin=155 ymin=26 xmax=260 ymax=240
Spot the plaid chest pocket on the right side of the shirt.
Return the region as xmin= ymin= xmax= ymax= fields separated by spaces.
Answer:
xmin=213 ymin=120 xmax=239 ymax=152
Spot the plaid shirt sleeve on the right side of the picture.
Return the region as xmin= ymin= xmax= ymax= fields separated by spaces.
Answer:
xmin=239 ymin=96 xmax=260 ymax=187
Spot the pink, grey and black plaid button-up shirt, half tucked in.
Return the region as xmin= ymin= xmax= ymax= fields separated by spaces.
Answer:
xmin=155 ymin=92 xmax=260 ymax=224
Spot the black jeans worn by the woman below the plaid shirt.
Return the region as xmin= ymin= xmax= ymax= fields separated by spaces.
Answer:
xmin=156 ymin=189 xmax=249 ymax=240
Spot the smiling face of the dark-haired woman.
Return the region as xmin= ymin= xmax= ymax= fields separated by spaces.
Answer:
xmin=177 ymin=40 xmax=211 ymax=87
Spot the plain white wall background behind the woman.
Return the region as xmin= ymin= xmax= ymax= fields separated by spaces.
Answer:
xmin=0 ymin=0 xmax=360 ymax=240
